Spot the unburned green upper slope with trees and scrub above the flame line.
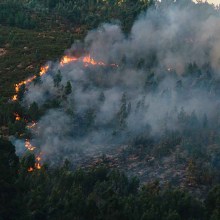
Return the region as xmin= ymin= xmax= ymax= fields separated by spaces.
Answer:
xmin=0 ymin=0 xmax=150 ymax=97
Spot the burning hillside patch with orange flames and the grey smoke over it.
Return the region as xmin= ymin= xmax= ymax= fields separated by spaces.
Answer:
xmin=8 ymin=1 xmax=219 ymax=186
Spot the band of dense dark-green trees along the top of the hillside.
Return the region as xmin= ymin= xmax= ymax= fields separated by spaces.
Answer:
xmin=6 ymin=0 xmax=151 ymax=29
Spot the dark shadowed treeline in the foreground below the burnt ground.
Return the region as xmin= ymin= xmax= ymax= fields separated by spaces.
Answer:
xmin=0 ymin=139 xmax=220 ymax=220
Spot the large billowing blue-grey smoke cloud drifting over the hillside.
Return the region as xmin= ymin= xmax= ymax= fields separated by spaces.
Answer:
xmin=19 ymin=1 xmax=220 ymax=161
